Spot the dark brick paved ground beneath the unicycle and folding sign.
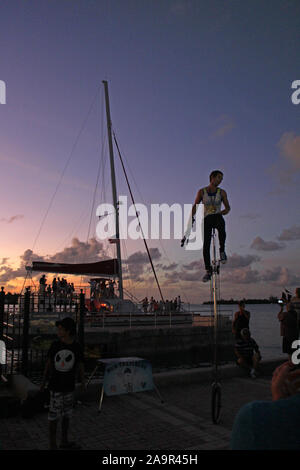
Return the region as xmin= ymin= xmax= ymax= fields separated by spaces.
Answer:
xmin=0 ymin=375 xmax=271 ymax=451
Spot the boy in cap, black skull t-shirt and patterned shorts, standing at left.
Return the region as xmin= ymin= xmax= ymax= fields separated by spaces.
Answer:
xmin=41 ymin=318 xmax=85 ymax=450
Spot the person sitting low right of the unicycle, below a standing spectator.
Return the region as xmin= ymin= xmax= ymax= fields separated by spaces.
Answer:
xmin=234 ymin=328 xmax=261 ymax=379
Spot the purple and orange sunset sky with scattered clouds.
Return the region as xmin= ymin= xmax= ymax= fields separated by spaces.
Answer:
xmin=0 ymin=0 xmax=300 ymax=303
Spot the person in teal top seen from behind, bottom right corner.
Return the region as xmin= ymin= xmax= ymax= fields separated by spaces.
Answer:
xmin=230 ymin=361 xmax=300 ymax=450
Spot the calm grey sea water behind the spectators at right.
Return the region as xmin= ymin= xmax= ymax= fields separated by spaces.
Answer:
xmin=190 ymin=304 xmax=287 ymax=359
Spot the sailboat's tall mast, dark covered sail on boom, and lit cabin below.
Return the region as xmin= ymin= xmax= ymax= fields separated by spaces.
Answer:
xmin=26 ymin=80 xmax=139 ymax=313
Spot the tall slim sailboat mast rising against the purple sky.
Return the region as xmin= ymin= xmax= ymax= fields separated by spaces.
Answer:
xmin=103 ymin=80 xmax=123 ymax=299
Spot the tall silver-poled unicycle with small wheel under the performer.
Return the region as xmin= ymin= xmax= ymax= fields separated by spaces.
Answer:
xmin=210 ymin=229 xmax=222 ymax=424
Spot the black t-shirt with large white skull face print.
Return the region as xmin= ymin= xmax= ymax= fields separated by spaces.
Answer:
xmin=48 ymin=341 xmax=83 ymax=392
